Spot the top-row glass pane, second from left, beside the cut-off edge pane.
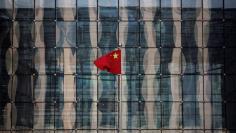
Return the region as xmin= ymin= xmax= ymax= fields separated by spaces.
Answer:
xmin=14 ymin=0 xmax=34 ymax=19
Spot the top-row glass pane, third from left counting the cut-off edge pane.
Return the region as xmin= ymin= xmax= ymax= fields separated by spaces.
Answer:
xmin=35 ymin=0 xmax=55 ymax=20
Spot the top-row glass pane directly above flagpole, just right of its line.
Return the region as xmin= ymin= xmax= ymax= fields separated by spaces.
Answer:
xmin=119 ymin=0 xmax=139 ymax=20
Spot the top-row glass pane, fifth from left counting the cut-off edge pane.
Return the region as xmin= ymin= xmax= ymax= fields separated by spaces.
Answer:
xmin=77 ymin=0 xmax=97 ymax=20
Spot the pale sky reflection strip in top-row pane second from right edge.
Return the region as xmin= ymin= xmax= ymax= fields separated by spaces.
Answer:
xmin=203 ymin=0 xmax=223 ymax=8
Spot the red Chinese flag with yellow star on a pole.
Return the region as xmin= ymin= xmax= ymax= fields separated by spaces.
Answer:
xmin=94 ymin=49 xmax=121 ymax=74
